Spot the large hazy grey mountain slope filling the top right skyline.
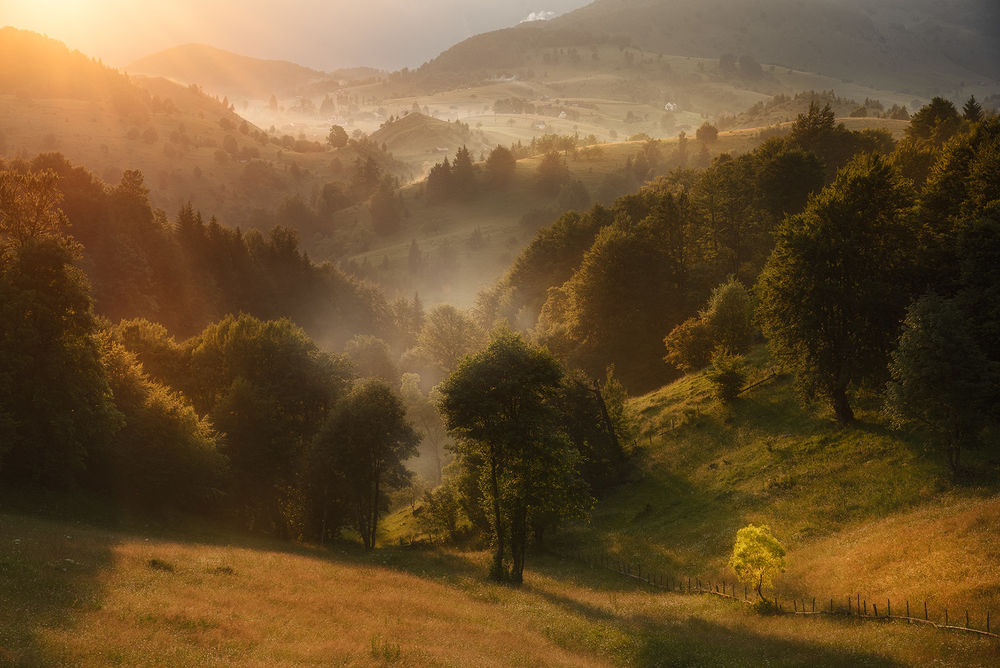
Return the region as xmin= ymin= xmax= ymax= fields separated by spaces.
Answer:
xmin=425 ymin=0 xmax=1000 ymax=96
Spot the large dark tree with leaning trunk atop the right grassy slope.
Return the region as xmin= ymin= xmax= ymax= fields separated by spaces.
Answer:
xmin=757 ymin=155 xmax=915 ymax=423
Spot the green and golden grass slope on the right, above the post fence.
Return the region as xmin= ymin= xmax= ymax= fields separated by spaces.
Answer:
xmin=556 ymin=349 xmax=1000 ymax=627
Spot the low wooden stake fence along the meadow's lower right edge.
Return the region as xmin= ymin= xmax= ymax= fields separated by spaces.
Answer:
xmin=557 ymin=552 xmax=1000 ymax=639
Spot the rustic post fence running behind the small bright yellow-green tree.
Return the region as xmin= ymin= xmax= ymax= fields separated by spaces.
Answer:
xmin=553 ymin=552 xmax=1000 ymax=639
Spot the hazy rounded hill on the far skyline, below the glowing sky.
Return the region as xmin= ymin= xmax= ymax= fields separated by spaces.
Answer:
xmin=126 ymin=44 xmax=378 ymax=99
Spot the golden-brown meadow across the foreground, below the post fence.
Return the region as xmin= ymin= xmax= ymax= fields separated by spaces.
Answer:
xmin=0 ymin=508 xmax=996 ymax=666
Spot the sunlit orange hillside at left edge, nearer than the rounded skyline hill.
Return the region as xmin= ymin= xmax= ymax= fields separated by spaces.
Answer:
xmin=0 ymin=28 xmax=402 ymax=230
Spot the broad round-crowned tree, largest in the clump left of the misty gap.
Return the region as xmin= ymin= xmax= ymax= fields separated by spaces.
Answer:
xmin=185 ymin=315 xmax=350 ymax=534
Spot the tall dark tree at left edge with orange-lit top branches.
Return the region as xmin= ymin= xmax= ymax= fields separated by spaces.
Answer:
xmin=0 ymin=171 xmax=121 ymax=485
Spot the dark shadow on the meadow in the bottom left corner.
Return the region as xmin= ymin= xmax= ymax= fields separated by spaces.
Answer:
xmin=0 ymin=514 xmax=115 ymax=666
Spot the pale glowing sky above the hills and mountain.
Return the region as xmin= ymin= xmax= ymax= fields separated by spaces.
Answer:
xmin=0 ymin=0 xmax=591 ymax=71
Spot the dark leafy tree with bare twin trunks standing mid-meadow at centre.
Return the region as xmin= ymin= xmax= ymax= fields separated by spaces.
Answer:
xmin=439 ymin=331 xmax=589 ymax=584
